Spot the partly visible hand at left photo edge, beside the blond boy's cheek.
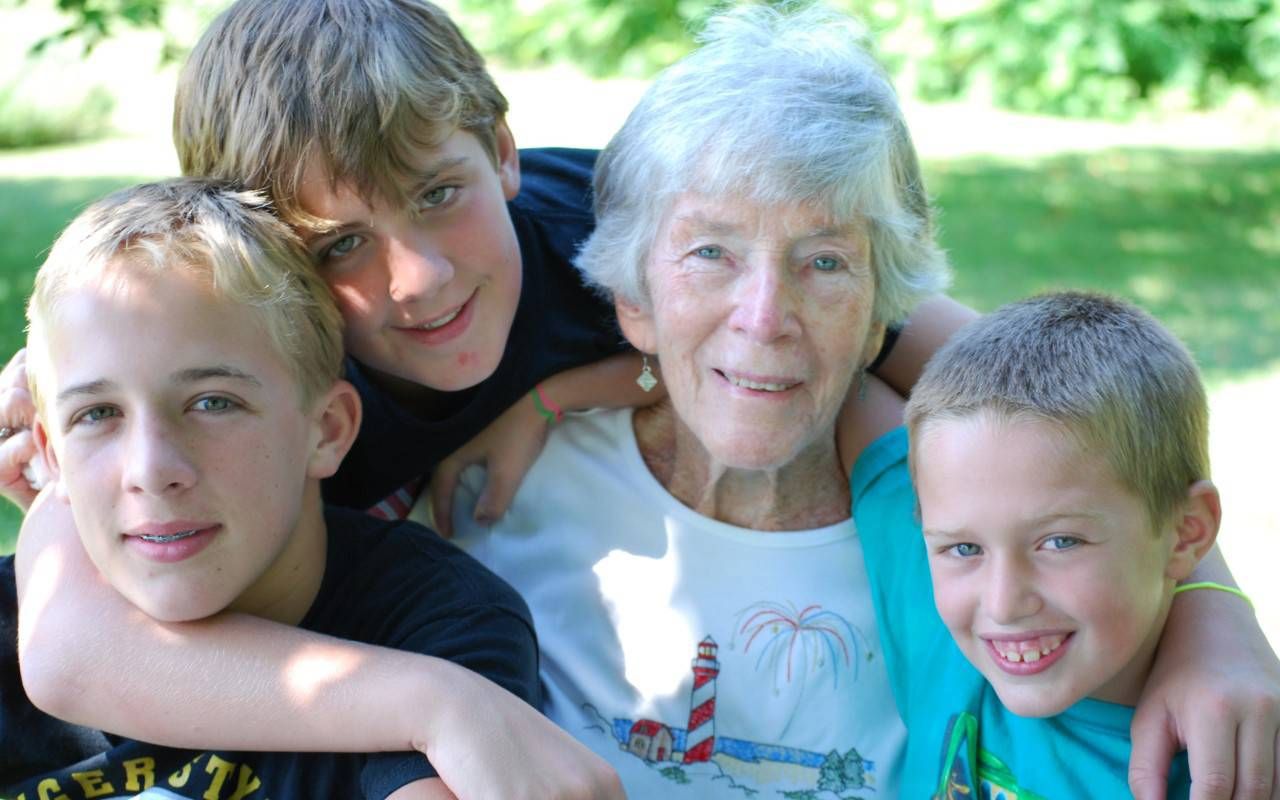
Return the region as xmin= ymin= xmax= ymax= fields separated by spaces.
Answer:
xmin=0 ymin=349 xmax=49 ymax=511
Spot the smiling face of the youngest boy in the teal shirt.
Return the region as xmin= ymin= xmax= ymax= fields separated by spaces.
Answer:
xmin=911 ymin=413 xmax=1175 ymax=717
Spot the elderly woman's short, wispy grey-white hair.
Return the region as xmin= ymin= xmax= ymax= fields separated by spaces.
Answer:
xmin=577 ymin=6 xmax=948 ymax=323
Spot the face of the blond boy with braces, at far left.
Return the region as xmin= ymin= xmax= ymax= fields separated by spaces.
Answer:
xmin=42 ymin=266 xmax=324 ymax=621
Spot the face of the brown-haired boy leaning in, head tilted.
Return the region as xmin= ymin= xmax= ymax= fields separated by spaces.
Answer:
xmin=298 ymin=124 xmax=521 ymax=392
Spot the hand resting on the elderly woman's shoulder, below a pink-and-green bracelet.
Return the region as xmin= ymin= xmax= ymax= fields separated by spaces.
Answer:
xmin=429 ymin=394 xmax=549 ymax=539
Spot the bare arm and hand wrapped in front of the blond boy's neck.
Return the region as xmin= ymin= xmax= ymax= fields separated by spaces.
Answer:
xmin=17 ymin=492 xmax=622 ymax=800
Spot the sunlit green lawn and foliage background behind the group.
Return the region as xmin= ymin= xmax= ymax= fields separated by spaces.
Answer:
xmin=0 ymin=0 xmax=1280 ymax=645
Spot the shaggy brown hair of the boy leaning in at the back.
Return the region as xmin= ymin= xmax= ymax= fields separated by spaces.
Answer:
xmin=173 ymin=0 xmax=507 ymax=227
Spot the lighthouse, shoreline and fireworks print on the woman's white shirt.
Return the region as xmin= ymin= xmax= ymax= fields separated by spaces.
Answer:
xmin=584 ymin=604 xmax=876 ymax=800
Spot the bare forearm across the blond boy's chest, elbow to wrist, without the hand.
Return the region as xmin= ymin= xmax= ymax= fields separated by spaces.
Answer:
xmin=17 ymin=488 xmax=462 ymax=751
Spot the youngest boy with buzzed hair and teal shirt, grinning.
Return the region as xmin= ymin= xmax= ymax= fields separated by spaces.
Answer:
xmin=854 ymin=293 xmax=1220 ymax=799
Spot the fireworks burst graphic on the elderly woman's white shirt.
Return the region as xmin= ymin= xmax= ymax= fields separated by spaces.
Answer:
xmin=730 ymin=602 xmax=870 ymax=686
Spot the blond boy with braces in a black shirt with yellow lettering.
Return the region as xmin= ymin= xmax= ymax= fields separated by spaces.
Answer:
xmin=4 ymin=180 xmax=553 ymax=799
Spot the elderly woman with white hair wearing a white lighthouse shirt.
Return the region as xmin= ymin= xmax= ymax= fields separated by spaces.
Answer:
xmin=454 ymin=8 xmax=1274 ymax=797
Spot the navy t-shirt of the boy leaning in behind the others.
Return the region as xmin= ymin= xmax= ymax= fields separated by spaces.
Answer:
xmin=324 ymin=148 xmax=628 ymax=509
